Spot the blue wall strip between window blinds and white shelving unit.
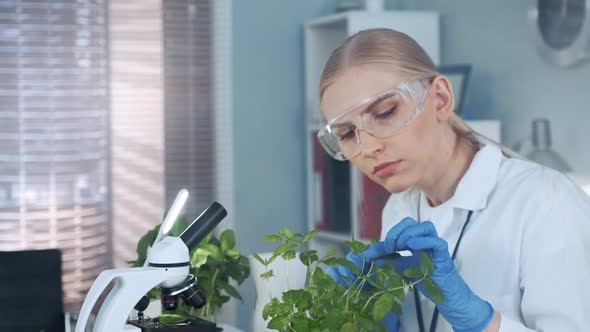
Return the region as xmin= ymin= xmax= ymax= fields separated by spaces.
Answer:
xmin=232 ymin=0 xmax=333 ymax=330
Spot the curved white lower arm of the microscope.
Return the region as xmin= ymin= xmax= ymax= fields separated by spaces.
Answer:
xmin=75 ymin=267 xmax=168 ymax=332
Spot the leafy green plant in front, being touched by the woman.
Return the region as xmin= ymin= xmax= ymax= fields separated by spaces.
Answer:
xmin=254 ymin=228 xmax=443 ymax=332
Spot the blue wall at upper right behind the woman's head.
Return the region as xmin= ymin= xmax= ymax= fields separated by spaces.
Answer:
xmin=408 ymin=0 xmax=590 ymax=174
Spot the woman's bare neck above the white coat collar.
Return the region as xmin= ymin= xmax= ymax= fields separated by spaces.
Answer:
xmin=419 ymin=132 xmax=476 ymax=206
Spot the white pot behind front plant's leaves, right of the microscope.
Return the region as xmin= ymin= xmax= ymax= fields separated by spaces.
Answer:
xmin=248 ymin=253 xmax=307 ymax=332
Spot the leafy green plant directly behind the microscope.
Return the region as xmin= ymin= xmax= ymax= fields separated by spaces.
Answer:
xmin=130 ymin=218 xmax=250 ymax=321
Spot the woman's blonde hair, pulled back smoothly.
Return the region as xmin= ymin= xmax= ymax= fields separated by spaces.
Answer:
xmin=319 ymin=29 xmax=484 ymax=149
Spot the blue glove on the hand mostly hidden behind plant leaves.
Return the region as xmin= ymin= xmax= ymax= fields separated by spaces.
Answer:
xmin=326 ymin=251 xmax=400 ymax=332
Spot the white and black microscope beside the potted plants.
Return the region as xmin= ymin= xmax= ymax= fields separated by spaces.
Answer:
xmin=75 ymin=189 xmax=227 ymax=332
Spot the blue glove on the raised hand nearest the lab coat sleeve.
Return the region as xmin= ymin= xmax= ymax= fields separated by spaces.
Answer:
xmin=361 ymin=217 xmax=494 ymax=332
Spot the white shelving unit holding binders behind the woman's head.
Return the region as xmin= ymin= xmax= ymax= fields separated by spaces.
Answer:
xmin=304 ymin=11 xmax=440 ymax=254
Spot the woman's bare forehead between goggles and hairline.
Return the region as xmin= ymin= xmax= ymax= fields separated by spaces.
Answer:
xmin=320 ymin=66 xmax=403 ymax=121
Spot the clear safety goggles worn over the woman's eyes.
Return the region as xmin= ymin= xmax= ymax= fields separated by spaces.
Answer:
xmin=317 ymin=79 xmax=428 ymax=160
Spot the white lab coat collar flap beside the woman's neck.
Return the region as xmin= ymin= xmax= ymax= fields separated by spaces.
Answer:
xmin=451 ymin=144 xmax=502 ymax=211
